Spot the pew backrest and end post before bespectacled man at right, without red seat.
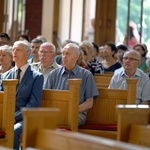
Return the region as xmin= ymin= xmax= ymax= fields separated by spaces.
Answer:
xmin=86 ymin=79 xmax=137 ymax=124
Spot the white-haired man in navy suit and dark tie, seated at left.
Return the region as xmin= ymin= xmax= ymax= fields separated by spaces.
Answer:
xmin=1 ymin=41 xmax=44 ymax=150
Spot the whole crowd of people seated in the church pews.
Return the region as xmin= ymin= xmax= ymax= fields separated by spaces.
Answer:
xmin=0 ymin=33 xmax=150 ymax=150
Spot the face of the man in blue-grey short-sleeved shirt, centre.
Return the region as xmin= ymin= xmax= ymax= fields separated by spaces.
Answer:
xmin=62 ymin=46 xmax=79 ymax=70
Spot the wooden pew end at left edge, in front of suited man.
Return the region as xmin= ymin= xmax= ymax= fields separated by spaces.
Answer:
xmin=0 ymin=79 xmax=18 ymax=148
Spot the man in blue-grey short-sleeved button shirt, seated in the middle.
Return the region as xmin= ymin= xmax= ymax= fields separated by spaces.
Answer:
xmin=44 ymin=43 xmax=99 ymax=125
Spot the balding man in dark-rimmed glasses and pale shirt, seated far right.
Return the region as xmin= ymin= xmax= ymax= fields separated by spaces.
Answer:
xmin=109 ymin=50 xmax=150 ymax=104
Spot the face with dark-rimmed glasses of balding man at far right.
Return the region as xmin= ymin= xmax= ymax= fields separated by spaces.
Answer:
xmin=123 ymin=52 xmax=139 ymax=70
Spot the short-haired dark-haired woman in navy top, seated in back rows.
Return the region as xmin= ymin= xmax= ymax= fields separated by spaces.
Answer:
xmin=102 ymin=42 xmax=122 ymax=72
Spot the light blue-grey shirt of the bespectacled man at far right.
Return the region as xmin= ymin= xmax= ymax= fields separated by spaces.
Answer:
xmin=109 ymin=67 xmax=150 ymax=104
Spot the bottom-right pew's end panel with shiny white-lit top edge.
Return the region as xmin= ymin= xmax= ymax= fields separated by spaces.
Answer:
xmin=116 ymin=105 xmax=150 ymax=142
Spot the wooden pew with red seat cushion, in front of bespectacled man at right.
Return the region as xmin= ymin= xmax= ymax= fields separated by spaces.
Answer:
xmin=79 ymin=79 xmax=138 ymax=139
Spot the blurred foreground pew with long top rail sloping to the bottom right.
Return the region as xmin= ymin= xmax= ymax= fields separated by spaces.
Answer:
xmin=23 ymin=108 xmax=149 ymax=150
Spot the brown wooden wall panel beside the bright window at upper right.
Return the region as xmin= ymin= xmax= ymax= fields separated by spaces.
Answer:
xmin=95 ymin=0 xmax=117 ymax=45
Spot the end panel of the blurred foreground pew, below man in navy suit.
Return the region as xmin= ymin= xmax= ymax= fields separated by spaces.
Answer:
xmin=22 ymin=108 xmax=60 ymax=149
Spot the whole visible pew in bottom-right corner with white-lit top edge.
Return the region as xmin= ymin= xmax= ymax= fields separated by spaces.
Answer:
xmin=117 ymin=105 xmax=150 ymax=147
